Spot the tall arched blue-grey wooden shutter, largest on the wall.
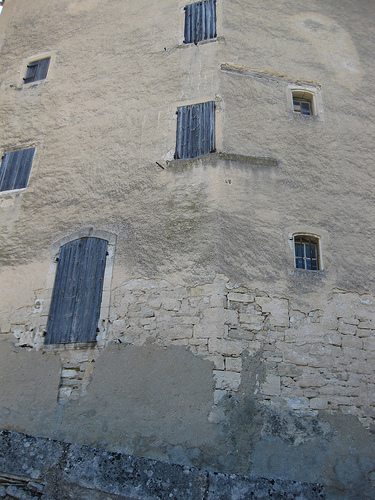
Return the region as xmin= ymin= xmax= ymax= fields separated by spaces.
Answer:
xmin=45 ymin=238 xmax=108 ymax=344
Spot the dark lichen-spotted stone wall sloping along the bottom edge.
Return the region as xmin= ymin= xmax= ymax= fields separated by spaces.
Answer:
xmin=0 ymin=430 xmax=325 ymax=500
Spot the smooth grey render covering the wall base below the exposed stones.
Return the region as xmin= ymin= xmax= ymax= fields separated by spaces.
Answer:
xmin=0 ymin=344 xmax=375 ymax=499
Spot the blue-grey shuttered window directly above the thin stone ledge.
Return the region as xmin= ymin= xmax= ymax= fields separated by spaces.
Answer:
xmin=176 ymin=101 xmax=215 ymax=162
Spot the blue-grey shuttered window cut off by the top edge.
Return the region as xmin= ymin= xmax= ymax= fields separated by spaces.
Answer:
xmin=184 ymin=0 xmax=216 ymax=44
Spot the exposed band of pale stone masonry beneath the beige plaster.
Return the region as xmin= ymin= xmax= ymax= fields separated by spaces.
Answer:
xmin=5 ymin=275 xmax=375 ymax=427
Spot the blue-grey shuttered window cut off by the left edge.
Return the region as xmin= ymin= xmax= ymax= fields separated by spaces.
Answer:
xmin=0 ymin=148 xmax=35 ymax=191
